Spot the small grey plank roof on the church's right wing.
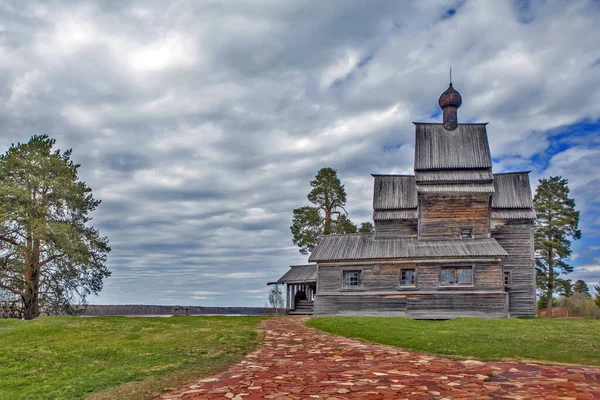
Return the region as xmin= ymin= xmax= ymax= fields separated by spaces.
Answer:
xmin=492 ymin=171 xmax=533 ymax=209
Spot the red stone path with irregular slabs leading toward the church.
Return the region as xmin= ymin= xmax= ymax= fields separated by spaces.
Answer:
xmin=159 ymin=317 xmax=600 ymax=400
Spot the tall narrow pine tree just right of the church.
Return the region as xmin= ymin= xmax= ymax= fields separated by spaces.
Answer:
xmin=533 ymin=176 xmax=581 ymax=317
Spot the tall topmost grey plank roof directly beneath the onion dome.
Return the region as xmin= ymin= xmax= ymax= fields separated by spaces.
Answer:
xmin=415 ymin=123 xmax=492 ymax=171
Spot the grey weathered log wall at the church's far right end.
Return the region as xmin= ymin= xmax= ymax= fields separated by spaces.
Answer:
xmin=492 ymin=220 xmax=536 ymax=317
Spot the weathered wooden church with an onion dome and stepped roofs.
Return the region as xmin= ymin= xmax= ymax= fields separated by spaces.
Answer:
xmin=277 ymin=83 xmax=535 ymax=319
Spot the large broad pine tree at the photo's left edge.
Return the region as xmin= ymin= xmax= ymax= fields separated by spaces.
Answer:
xmin=0 ymin=135 xmax=110 ymax=319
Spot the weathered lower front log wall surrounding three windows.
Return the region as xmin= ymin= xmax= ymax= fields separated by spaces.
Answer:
xmin=315 ymin=260 xmax=507 ymax=319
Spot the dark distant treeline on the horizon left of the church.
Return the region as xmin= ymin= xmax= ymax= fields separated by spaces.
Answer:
xmin=81 ymin=304 xmax=265 ymax=316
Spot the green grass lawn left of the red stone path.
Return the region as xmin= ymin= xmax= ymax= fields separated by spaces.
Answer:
xmin=0 ymin=317 xmax=263 ymax=400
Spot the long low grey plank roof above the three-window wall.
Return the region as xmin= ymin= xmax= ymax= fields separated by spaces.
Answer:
xmin=308 ymin=233 xmax=508 ymax=262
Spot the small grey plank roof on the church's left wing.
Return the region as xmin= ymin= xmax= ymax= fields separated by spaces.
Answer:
xmin=373 ymin=175 xmax=417 ymax=210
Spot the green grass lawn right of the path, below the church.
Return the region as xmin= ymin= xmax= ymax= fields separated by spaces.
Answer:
xmin=307 ymin=317 xmax=600 ymax=365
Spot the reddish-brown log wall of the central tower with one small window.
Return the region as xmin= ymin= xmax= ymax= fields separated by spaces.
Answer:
xmin=419 ymin=193 xmax=490 ymax=238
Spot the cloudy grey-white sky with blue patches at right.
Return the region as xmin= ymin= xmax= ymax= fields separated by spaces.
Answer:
xmin=0 ymin=0 xmax=600 ymax=306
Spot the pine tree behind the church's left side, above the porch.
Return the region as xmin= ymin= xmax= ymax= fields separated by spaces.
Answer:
xmin=290 ymin=168 xmax=357 ymax=255
